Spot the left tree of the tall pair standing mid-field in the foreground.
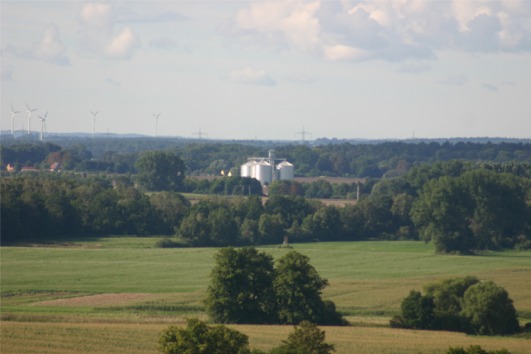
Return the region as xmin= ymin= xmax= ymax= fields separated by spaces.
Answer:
xmin=206 ymin=248 xmax=276 ymax=323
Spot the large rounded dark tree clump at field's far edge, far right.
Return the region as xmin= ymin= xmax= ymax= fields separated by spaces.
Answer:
xmin=411 ymin=170 xmax=529 ymax=253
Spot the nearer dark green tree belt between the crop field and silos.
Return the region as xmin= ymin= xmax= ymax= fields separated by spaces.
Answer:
xmin=1 ymin=155 xmax=531 ymax=253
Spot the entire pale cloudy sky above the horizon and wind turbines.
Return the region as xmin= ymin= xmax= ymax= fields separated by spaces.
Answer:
xmin=0 ymin=0 xmax=531 ymax=140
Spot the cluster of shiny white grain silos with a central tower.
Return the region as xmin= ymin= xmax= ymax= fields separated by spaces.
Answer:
xmin=240 ymin=150 xmax=294 ymax=185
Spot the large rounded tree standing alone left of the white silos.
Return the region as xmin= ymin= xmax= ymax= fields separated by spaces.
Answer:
xmin=135 ymin=151 xmax=185 ymax=191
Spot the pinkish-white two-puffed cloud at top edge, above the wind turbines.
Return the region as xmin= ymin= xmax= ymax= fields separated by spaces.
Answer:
xmin=79 ymin=3 xmax=140 ymax=59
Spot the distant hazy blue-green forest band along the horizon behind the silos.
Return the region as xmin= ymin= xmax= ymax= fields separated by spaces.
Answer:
xmin=1 ymin=138 xmax=531 ymax=178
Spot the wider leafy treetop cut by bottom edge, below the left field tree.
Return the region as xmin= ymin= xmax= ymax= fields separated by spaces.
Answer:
xmin=159 ymin=319 xmax=250 ymax=354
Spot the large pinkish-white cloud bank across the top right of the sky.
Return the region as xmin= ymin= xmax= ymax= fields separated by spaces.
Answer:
xmin=231 ymin=0 xmax=531 ymax=61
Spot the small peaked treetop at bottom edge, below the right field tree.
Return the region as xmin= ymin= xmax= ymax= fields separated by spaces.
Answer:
xmin=270 ymin=321 xmax=335 ymax=354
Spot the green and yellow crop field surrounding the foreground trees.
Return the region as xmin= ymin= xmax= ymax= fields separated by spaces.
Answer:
xmin=0 ymin=237 xmax=531 ymax=353
